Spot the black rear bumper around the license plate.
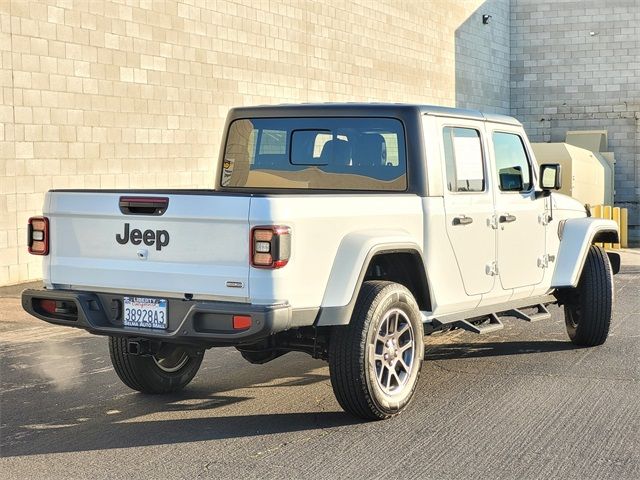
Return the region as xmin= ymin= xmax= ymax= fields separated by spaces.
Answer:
xmin=22 ymin=290 xmax=291 ymax=346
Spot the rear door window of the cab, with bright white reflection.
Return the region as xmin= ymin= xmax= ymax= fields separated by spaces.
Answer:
xmin=443 ymin=127 xmax=484 ymax=192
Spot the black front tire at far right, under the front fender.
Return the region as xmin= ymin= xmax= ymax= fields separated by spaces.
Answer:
xmin=564 ymin=245 xmax=614 ymax=347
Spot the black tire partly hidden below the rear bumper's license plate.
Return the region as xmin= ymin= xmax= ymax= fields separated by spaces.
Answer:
xmin=109 ymin=337 xmax=203 ymax=394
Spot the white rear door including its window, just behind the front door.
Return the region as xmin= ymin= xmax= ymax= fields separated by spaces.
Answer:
xmin=438 ymin=119 xmax=496 ymax=295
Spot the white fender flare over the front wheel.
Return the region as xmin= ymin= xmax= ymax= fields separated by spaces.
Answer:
xmin=551 ymin=217 xmax=620 ymax=288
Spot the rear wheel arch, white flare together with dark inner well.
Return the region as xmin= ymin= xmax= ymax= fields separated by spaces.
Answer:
xmin=316 ymin=233 xmax=431 ymax=326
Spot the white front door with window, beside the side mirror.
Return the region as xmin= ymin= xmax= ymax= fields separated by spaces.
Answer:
xmin=489 ymin=126 xmax=546 ymax=290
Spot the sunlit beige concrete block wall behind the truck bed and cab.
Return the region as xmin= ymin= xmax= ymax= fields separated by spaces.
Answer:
xmin=0 ymin=0 xmax=508 ymax=285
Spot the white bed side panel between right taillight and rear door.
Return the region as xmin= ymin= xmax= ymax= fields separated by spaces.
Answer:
xmin=249 ymin=192 xmax=423 ymax=308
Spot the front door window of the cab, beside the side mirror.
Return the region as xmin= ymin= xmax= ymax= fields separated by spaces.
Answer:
xmin=493 ymin=132 xmax=531 ymax=192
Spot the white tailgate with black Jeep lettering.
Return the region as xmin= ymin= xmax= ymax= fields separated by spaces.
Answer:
xmin=45 ymin=191 xmax=251 ymax=301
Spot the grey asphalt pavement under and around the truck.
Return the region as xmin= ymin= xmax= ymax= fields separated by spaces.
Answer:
xmin=0 ymin=251 xmax=640 ymax=480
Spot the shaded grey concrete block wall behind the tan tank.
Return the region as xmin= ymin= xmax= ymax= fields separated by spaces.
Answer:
xmin=511 ymin=0 xmax=640 ymax=244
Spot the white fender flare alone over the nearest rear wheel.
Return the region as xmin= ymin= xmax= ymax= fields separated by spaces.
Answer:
xmin=316 ymin=230 xmax=428 ymax=327
